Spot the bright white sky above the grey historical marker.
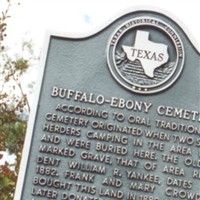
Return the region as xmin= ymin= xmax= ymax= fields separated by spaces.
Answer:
xmin=0 ymin=0 xmax=200 ymax=164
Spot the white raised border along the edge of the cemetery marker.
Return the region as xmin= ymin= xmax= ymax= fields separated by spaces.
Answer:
xmin=14 ymin=5 xmax=200 ymax=200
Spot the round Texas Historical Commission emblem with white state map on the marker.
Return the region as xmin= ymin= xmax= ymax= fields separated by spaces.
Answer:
xmin=107 ymin=17 xmax=184 ymax=94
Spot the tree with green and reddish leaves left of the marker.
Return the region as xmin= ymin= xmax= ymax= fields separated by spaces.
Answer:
xmin=0 ymin=0 xmax=38 ymax=200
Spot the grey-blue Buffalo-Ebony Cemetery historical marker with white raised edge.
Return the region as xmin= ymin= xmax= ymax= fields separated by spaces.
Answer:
xmin=15 ymin=10 xmax=200 ymax=200
